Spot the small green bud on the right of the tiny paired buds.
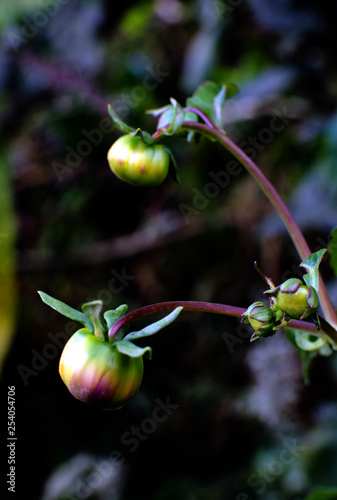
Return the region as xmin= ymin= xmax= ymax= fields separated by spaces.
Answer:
xmin=271 ymin=278 xmax=319 ymax=319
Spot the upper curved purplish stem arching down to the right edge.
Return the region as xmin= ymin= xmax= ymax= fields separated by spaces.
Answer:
xmin=153 ymin=122 xmax=337 ymax=328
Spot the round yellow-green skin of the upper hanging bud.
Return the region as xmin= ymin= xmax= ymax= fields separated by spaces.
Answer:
xmin=108 ymin=135 xmax=170 ymax=187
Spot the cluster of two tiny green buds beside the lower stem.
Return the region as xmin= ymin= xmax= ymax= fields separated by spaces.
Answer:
xmin=242 ymin=278 xmax=319 ymax=341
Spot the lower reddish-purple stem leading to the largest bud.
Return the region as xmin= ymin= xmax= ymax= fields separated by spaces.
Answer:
xmin=109 ymin=300 xmax=337 ymax=343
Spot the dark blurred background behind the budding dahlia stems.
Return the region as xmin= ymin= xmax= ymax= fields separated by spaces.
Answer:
xmin=0 ymin=0 xmax=337 ymax=500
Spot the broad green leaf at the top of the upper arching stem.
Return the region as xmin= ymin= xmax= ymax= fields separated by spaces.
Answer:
xmin=186 ymin=81 xmax=238 ymax=128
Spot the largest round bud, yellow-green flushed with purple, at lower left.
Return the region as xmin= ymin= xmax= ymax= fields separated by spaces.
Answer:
xmin=59 ymin=328 xmax=143 ymax=410
